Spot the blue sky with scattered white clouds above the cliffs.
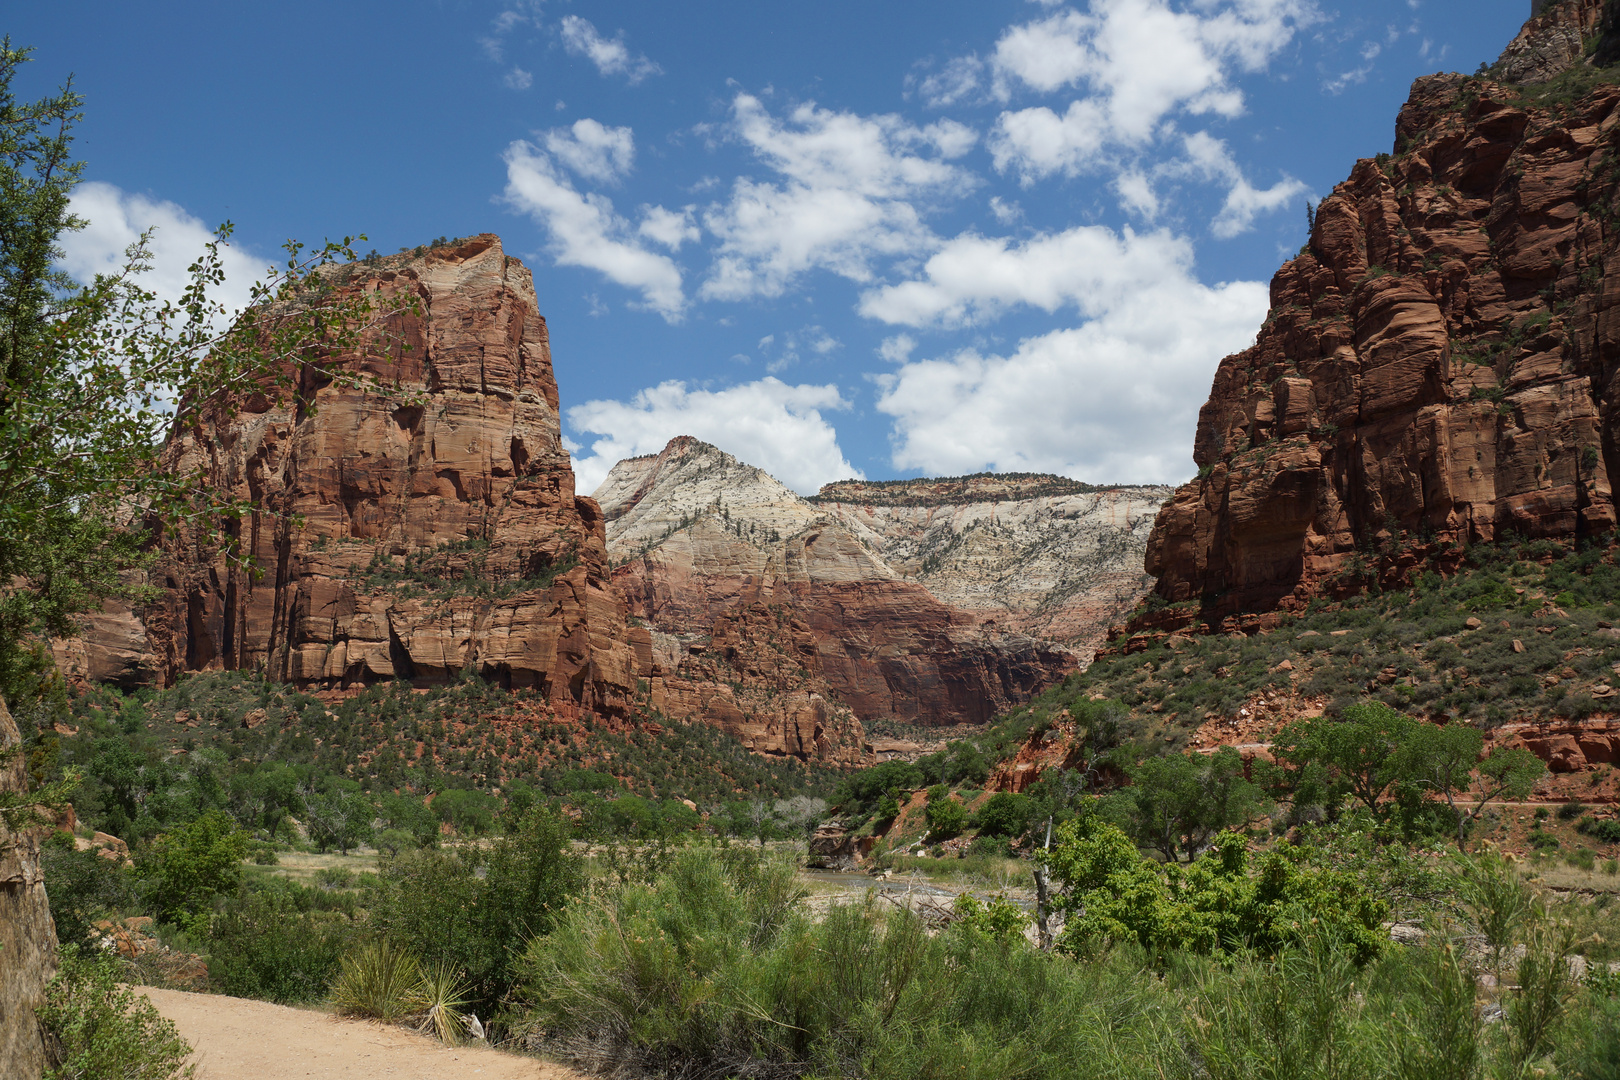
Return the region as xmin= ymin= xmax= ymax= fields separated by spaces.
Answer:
xmin=6 ymin=0 xmax=1529 ymax=492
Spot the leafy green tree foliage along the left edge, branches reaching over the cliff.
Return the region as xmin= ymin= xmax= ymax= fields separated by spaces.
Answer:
xmin=0 ymin=37 xmax=395 ymax=704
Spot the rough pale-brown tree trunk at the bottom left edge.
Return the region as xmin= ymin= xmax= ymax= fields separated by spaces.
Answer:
xmin=0 ymin=701 xmax=57 ymax=1080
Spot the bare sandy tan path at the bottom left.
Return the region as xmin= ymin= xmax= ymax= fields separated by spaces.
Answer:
xmin=138 ymin=986 xmax=585 ymax=1080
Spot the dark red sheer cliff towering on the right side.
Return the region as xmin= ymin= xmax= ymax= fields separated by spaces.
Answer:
xmin=1145 ymin=40 xmax=1620 ymax=622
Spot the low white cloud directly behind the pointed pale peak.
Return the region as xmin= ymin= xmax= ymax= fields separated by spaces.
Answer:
xmin=567 ymin=377 xmax=863 ymax=495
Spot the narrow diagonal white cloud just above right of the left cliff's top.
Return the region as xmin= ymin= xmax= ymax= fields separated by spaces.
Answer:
xmin=504 ymin=137 xmax=685 ymax=322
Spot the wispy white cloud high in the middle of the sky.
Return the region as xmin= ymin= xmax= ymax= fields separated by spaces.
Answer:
xmin=701 ymin=94 xmax=977 ymax=300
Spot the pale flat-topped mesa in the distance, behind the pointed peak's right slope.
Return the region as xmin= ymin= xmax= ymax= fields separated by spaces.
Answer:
xmin=813 ymin=473 xmax=1171 ymax=653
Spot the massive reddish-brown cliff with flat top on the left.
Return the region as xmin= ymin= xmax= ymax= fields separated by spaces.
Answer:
xmin=147 ymin=235 xmax=635 ymax=714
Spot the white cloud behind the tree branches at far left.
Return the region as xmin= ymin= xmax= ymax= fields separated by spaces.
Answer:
xmin=60 ymin=180 xmax=269 ymax=320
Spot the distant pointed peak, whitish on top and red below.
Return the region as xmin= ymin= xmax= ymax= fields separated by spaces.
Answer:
xmin=596 ymin=437 xmax=1077 ymax=725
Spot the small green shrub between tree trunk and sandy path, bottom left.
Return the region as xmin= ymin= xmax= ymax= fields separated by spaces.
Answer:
xmin=37 ymin=944 xmax=194 ymax=1080
